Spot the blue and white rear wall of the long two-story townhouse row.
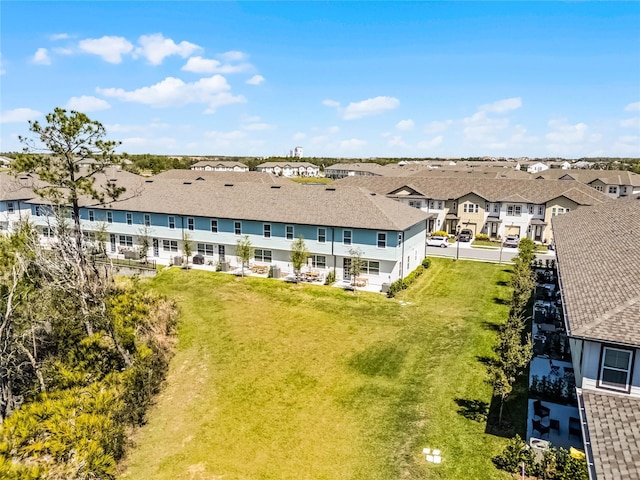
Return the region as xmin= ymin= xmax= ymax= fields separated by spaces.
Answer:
xmin=25 ymin=205 xmax=426 ymax=285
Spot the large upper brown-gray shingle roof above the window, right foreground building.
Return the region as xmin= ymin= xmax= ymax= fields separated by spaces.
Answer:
xmin=552 ymin=200 xmax=640 ymax=345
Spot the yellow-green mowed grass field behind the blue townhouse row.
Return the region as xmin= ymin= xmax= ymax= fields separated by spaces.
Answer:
xmin=120 ymin=259 xmax=510 ymax=480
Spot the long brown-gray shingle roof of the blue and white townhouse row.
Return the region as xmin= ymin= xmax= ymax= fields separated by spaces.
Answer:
xmin=69 ymin=176 xmax=428 ymax=231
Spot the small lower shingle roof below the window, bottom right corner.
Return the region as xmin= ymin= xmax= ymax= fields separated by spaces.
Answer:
xmin=582 ymin=390 xmax=640 ymax=480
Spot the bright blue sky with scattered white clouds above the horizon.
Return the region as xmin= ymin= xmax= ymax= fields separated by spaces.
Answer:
xmin=0 ymin=0 xmax=640 ymax=158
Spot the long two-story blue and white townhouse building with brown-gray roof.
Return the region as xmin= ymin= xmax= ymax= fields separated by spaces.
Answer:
xmin=0 ymin=171 xmax=427 ymax=288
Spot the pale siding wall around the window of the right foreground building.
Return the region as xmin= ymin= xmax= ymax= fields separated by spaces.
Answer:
xmin=572 ymin=339 xmax=640 ymax=397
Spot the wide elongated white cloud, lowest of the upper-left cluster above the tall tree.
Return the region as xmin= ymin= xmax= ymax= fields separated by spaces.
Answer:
xmin=96 ymin=75 xmax=246 ymax=113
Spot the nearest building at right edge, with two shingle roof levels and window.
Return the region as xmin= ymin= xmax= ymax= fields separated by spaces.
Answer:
xmin=552 ymin=200 xmax=640 ymax=480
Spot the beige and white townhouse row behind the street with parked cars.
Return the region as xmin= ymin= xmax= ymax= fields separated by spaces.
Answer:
xmin=335 ymin=176 xmax=608 ymax=243
